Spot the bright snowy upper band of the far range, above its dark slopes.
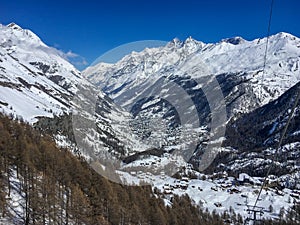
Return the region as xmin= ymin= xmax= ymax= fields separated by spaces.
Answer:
xmin=83 ymin=33 xmax=300 ymax=111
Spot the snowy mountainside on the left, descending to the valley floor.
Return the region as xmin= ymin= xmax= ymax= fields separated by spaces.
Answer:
xmin=0 ymin=23 xmax=146 ymax=162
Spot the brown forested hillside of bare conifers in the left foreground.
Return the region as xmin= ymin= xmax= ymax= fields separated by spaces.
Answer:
xmin=0 ymin=115 xmax=227 ymax=225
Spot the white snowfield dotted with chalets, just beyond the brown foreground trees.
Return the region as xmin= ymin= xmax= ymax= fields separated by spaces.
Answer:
xmin=119 ymin=168 xmax=297 ymax=219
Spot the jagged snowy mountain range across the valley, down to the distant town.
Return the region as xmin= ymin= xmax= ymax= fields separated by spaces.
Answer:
xmin=83 ymin=33 xmax=300 ymax=171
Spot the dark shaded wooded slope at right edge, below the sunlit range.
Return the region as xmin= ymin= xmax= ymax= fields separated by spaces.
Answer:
xmin=218 ymin=82 xmax=300 ymax=181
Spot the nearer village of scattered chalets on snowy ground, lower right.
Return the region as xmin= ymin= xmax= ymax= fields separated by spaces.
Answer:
xmin=120 ymin=156 xmax=300 ymax=219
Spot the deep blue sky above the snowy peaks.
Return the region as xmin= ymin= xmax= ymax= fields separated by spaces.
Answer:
xmin=0 ymin=0 xmax=300 ymax=69
